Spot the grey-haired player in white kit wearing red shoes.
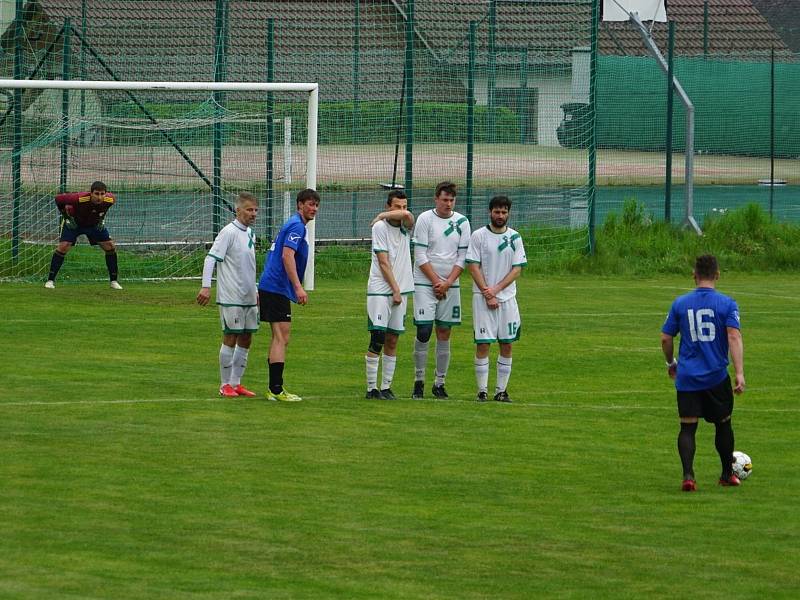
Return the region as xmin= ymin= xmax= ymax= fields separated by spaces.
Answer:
xmin=197 ymin=192 xmax=258 ymax=398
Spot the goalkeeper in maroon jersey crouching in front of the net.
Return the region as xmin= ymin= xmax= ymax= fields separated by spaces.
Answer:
xmin=44 ymin=181 xmax=122 ymax=290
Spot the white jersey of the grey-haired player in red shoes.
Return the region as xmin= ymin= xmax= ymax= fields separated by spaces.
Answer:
xmin=208 ymin=220 xmax=258 ymax=306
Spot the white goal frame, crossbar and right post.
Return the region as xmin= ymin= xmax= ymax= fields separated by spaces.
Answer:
xmin=0 ymin=79 xmax=319 ymax=290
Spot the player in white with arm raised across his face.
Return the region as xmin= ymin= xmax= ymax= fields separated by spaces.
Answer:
xmin=364 ymin=190 xmax=414 ymax=400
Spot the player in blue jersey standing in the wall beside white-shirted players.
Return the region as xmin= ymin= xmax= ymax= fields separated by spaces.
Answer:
xmin=258 ymin=189 xmax=320 ymax=402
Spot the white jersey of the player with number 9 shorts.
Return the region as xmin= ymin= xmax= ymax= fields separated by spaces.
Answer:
xmin=412 ymin=209 xmax=470 ymax=287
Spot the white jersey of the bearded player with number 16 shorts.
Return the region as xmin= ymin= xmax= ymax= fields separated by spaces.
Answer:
xmin=467 ymin=225 xmax=528 ymax=302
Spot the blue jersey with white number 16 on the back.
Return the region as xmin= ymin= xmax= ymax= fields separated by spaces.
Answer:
xmin=661 ymin=287 xmax=739 ymax=392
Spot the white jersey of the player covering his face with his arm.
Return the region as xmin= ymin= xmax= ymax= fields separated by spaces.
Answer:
xmin=367 ymin=220 xmax=414 ymax=296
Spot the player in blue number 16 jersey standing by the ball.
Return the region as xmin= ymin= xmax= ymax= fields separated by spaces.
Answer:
xmin=661 ymin=254 xmax=745 ymax=492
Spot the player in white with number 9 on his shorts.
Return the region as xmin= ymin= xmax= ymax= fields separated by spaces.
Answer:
xmin=411 ymin=181 xmax=470 ymax=398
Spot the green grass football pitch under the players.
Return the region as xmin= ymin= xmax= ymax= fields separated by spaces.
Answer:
xmin=0 ymin=273 xmax=800 ymax=599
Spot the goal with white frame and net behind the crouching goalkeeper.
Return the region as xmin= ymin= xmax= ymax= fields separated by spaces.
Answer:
xmin=0 ymin=80 xmax=318 ymax=288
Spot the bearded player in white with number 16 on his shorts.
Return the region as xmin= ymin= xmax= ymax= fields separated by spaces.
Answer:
xmin=467 ymin=196 xmax=527 ymax=402
